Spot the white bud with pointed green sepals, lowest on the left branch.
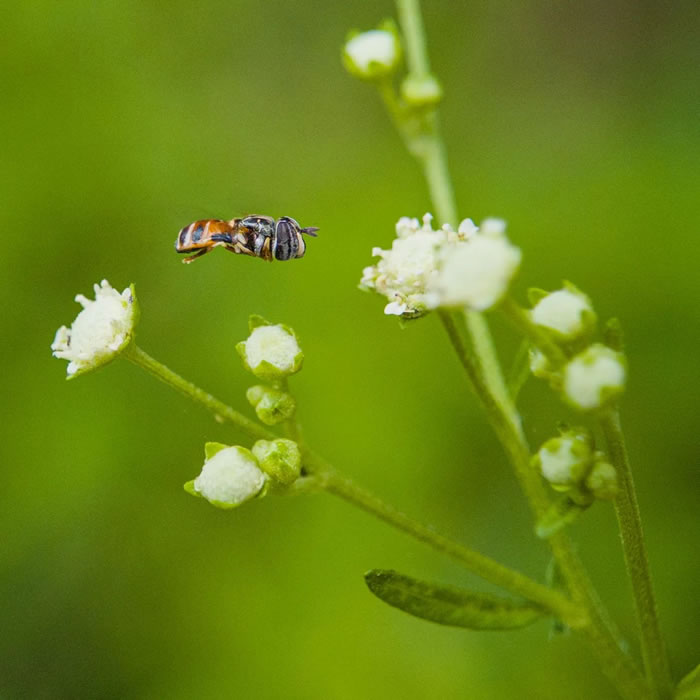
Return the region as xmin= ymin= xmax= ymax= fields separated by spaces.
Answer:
xmin=185 ymin=442 xmax=267 ymax=509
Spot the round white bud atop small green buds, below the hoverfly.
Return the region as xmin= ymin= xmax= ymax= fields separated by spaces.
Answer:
xmin=236 ymin=316 xmax=304 ymax=381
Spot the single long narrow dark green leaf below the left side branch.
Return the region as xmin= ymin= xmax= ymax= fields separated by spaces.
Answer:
xmin=365 ymin=569 xmax=547 ymax=630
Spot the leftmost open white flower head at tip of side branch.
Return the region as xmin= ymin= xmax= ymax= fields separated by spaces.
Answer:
xmin=51 ymin=280 xmax=138 ymax=379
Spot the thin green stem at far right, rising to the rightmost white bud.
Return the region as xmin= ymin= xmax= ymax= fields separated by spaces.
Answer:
xmin=600 ymin=408 xmax=672 ymax=698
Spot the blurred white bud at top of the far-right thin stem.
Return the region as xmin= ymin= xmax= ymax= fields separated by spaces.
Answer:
xmin=563 ymin=343 xmax=626 ymax=410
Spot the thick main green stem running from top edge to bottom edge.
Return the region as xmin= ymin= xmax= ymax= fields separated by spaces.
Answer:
xmin=396 ymin=0 xmax=650 ymax=700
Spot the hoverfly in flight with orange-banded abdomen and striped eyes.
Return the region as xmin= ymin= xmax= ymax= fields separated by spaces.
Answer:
xmin=175 ymin=215 xmax=318 ymax=263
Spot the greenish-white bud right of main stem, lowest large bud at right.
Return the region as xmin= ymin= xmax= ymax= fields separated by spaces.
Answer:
xmin=533 ymin=429 xmax=593 ymax=491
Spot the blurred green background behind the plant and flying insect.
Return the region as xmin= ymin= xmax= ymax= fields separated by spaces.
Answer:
xmin=0 ymin=0 xmax=700 ymax=700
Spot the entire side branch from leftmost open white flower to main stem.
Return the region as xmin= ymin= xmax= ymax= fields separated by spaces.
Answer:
xmin=125 ymin=344 xmax=588 ymax=628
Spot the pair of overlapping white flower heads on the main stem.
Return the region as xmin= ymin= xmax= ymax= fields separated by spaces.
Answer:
xmin=360 ymin=214 xmax=520 ymax=319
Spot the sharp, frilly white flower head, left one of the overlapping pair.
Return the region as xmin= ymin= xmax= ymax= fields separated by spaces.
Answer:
xmin=360 ymin=214 xmax=457 ymax=318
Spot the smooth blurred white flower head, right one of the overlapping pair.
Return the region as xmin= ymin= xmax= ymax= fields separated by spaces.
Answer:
xmin=429 ymin=228 xmax=521 ymax=311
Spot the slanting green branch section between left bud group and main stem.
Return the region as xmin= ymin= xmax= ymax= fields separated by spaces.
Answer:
xmin=321 ymin=464 xmax=588 ymax=628
